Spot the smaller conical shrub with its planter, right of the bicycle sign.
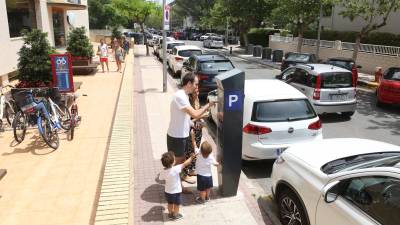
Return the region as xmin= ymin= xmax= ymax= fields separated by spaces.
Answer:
xmin=67 ymin=27 xmax=94 ymax=66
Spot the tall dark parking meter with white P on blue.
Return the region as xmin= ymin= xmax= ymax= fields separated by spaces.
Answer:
xmin=216 ymin=69 xmax=245 ymax=197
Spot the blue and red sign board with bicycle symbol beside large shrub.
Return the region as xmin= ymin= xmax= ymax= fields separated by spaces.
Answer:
xmin=50 ymin=54 xmax=74 ymax=92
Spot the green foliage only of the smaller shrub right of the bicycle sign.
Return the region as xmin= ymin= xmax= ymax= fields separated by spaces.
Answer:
xmin=67 ymin=27 xmax=94 ymax=58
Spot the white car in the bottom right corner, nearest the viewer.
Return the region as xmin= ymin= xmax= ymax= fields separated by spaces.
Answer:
xmin=272 ymin=138 xmax=400 ymax=225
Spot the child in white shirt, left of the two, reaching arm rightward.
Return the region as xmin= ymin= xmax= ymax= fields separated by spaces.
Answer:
xmin=160 ymin=152 xmax=195 ymax=220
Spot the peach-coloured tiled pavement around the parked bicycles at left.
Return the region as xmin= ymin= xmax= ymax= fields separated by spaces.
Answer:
xmin=0 ymin=44 xmax=132 ymax=225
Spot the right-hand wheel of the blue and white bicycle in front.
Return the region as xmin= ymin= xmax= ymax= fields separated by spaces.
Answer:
xmin=38 ymin=116 xmax=60 ymax=150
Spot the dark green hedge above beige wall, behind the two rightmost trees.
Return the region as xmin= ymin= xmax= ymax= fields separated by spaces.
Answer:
xmin=304 ymin=30 xmax=400 ymax=46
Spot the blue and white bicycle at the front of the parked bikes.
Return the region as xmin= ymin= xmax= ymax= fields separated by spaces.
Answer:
xmin=13 ymin=90 xmax=61 ymax=150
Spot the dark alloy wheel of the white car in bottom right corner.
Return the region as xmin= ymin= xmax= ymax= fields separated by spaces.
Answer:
xmin=278 ymin=189 xmax=309 ymax=225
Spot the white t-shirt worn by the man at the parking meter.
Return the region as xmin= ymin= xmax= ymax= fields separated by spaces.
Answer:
xmin=168 ymin=90 xmax=190 ymax=138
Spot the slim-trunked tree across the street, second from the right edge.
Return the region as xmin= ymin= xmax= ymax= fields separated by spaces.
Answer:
xmin=272 ymin=0 xmax=320 ymax=52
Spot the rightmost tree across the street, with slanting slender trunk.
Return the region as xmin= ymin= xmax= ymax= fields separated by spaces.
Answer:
xmin=336 ymin=0 xmax=400 ymax=60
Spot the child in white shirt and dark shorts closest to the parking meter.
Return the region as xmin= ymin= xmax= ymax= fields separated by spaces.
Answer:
xmin=192 ymin=132 xmax=219 ymax=204
